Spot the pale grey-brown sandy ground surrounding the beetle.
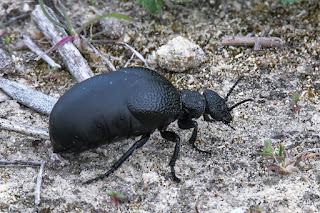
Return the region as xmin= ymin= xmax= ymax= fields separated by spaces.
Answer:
xmin=0 ymin=0 xmax=320 ymax=212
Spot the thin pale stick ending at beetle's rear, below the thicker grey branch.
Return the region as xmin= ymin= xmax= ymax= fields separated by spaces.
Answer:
xmin=0 ymin=118 xmax=50 ymax=140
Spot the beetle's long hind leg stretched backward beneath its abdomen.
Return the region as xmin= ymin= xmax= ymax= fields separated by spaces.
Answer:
xmin=84 ymin=133 xmax=150 ymax=184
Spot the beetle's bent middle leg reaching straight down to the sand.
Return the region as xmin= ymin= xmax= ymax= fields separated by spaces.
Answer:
xmin=160 ymin=131 xmax=181 ymax=182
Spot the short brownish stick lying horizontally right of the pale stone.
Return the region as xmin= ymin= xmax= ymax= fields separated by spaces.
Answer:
xmin=221 ymin=36 xmax=284 ymax=50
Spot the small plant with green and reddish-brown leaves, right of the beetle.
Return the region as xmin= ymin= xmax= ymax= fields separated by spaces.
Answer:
xmin=257 ymin=140 xmax=320 ymax=178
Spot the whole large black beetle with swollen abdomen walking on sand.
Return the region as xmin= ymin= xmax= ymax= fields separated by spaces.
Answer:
xmin=49 ymin=67 xmax=252 ymax=183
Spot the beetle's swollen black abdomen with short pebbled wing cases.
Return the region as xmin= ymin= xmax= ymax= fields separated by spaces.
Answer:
xmin=49 ymin=68 xmax=182 ymax=152
